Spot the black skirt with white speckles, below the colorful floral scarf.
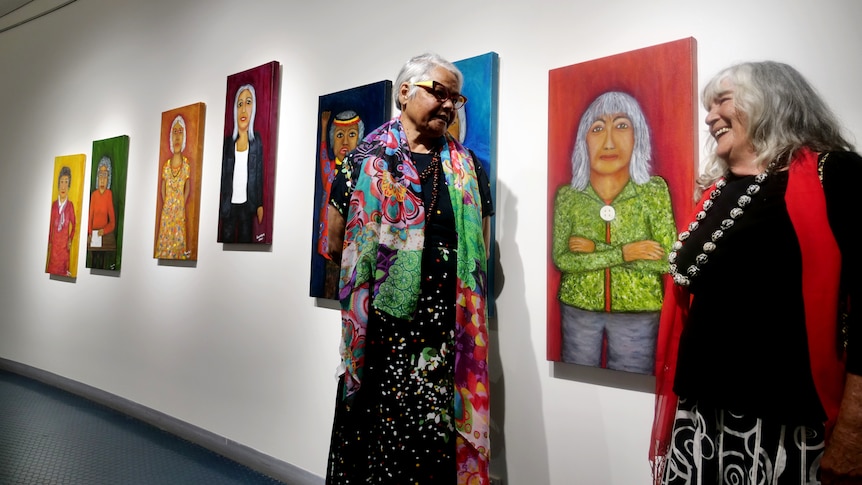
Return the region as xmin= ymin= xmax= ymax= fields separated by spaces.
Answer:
xmin=326 ymin=247 xmax=457 ymax=485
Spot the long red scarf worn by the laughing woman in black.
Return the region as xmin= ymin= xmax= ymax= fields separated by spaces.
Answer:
xmin=649 ymin=148 xmax=844 ymax=483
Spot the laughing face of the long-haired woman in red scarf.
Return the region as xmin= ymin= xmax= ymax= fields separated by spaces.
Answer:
xmin=705 ymin=82 xmax=756 ymax=167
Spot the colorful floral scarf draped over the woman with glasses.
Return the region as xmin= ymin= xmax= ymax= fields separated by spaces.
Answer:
xmin=339 ymin=118 xmax=490 ymax=483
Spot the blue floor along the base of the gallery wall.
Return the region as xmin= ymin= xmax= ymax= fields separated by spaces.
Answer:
xmin=0 ymin=370 xmax=290 ymax=485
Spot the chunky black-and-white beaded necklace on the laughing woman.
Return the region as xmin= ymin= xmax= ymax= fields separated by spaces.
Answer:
xmin=667 ymin=162 xmax=775 ymax=286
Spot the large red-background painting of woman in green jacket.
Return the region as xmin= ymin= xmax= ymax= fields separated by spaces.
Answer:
xmin=547 ymin=38 xmax=697 ymax=374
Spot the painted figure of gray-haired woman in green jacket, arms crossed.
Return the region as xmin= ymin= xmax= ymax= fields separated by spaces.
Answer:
xmin=552 ymin=91 xmax=676 ymax=374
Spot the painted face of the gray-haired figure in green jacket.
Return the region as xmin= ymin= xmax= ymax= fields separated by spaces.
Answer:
xmin=586 ymin=113 xmax=635 ymax=175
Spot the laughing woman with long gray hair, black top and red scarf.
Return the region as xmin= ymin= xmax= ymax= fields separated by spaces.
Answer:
xmin=650 ymin=61 xmax=862 ymax=485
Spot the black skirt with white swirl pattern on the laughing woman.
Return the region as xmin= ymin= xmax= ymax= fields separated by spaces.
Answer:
xmin=662 ymin=399 xmax=824 ymax=485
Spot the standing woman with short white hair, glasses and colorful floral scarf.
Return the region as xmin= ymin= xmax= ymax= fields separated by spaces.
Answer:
xmin=327 ymin=54 xmax=493 ymax=484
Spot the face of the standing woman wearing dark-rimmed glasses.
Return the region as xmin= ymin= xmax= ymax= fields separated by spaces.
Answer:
xmin=399 ymin=67 xmax=458 ymax=137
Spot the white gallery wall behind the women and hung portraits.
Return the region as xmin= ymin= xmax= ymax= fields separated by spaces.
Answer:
xmin=0 ymin=0 xmax=862 ymax=485
